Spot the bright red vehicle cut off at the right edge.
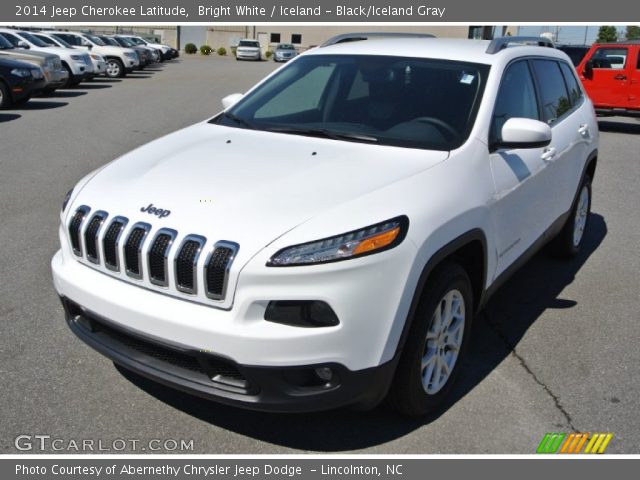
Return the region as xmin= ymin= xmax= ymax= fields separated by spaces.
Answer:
xmin=577 ymin=40 xmax=640 ymax=117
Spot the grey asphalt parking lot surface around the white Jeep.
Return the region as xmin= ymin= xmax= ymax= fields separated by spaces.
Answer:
xmin=0 ymin=56 xmax=640 ymax=454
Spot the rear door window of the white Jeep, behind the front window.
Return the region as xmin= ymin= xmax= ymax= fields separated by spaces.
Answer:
xmin=531 ymin=60 xmax=571 ymax=124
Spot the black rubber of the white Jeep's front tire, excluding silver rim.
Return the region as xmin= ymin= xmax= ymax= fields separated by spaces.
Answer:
xmin=387 ymin=262 xmax=473 ymax=417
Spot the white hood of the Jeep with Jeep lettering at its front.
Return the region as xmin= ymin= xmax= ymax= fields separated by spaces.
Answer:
xmin=72 ymin=123 xmax=448 ymax=263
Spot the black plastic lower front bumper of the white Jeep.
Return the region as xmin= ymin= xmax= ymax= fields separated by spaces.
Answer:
xmin=61 ymin=297 xmax=395 ymax=412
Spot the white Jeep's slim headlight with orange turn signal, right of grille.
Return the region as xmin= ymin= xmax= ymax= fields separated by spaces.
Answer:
xmin=267 ymin=216 xmax=409 ymax=267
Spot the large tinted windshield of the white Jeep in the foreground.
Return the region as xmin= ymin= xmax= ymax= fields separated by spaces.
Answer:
xmin=211 ymin=55 xmax=489 ymax=150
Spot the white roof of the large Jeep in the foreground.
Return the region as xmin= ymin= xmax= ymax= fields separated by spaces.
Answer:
xmin=305 ymin=37 xmax=566 ymax=65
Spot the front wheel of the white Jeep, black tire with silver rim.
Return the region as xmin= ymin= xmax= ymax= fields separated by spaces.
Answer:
xmin=388 ymin=263 xmax=473 ymax=417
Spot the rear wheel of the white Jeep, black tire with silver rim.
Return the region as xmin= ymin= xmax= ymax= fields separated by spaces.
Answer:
xmin=550 ymin=175 xmax=591 ymax=258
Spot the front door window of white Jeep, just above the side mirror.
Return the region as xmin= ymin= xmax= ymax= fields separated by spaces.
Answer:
xmin=490 ymin=60 xmax=540 ymax=143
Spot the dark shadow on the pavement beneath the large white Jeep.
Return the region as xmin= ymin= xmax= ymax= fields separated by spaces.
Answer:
xmin=116 ymin=214 xmax=607 ymax=452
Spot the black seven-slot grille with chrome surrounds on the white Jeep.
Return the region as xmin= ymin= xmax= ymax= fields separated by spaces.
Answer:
xmin=67 ymin=205 xmax=239 ymax=301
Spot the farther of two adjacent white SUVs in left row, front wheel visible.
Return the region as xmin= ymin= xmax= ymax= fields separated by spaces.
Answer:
xmin=47 ymin=31 xmax=140 ymax=78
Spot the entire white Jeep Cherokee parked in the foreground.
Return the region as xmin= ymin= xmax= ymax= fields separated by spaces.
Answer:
xmin=52 ymin=34 xmax=598 ymax=415
